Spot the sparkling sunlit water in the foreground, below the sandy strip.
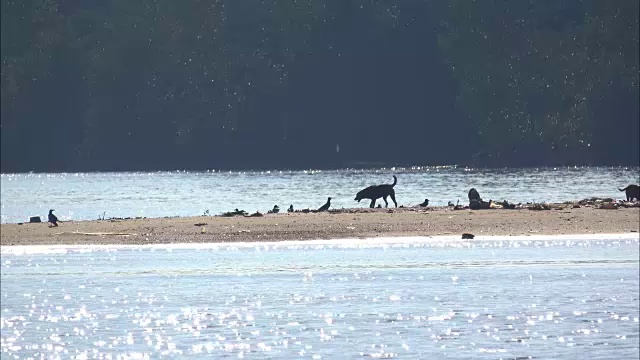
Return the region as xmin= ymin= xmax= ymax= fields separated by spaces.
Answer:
xmin=0 ymin=235 xmax=640 ymax=359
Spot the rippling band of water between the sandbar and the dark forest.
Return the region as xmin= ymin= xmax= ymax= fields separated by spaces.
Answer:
xmin=0 ymin=167 xmax=640 ymax=223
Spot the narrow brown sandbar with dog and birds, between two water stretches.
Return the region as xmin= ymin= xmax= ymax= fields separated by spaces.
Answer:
xmin=0 ymin=205 xmax=640 ymax=246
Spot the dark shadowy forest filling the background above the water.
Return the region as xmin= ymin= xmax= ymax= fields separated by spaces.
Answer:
xmin=1 ymin=0 xmax=640 ymax=172
